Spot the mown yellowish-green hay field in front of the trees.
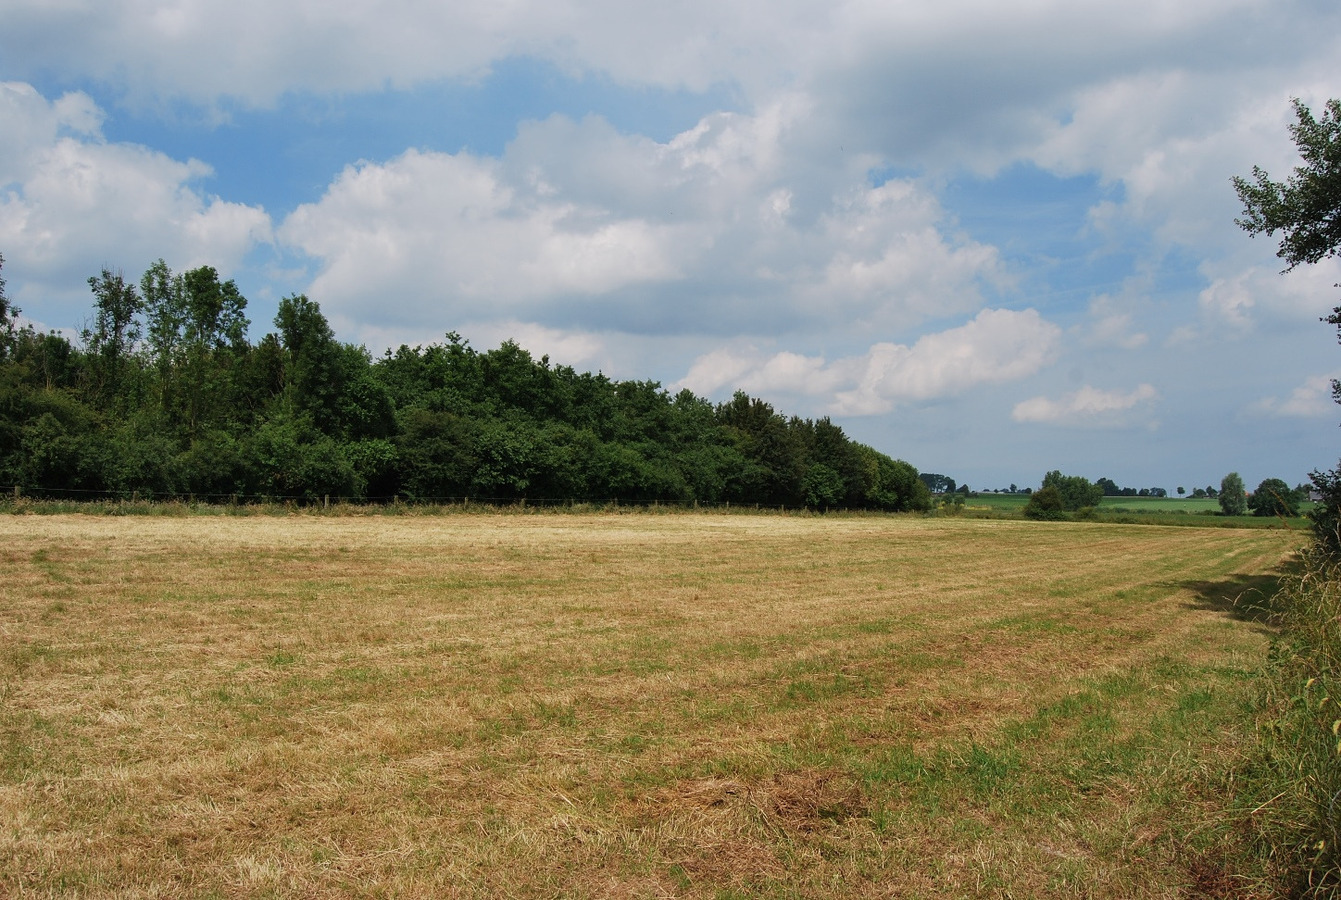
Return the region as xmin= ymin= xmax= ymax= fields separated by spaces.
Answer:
xmin=0 ymin=514 xmax=1301 ymax=897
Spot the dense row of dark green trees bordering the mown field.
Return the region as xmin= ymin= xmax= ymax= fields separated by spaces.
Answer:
xmin=0 ymin=258 xmax=929 ymax=511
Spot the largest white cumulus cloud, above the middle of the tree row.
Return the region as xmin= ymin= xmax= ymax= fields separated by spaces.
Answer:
xmin=279 ymin=105 xmax=1008 ymax=342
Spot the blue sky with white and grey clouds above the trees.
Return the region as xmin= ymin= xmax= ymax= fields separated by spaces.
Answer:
xmin=0 ymin=0 xmax=1341 ymax=492
